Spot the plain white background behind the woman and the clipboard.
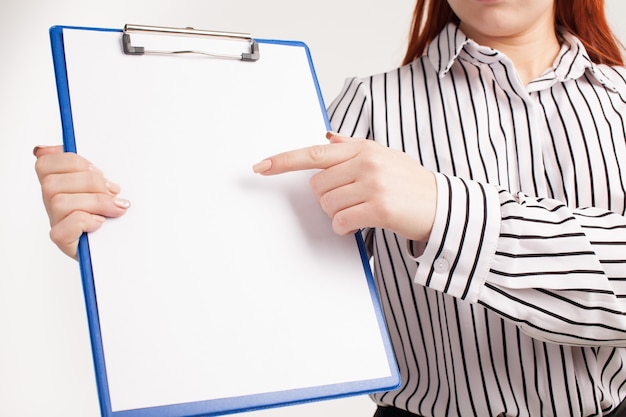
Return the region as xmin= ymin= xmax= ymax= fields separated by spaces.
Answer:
xmin=0 ymin=0 xmax=626 ymax=417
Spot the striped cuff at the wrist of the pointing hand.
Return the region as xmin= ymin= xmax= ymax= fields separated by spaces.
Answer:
xmin=414 ymin=173 xmax=501 ymax=302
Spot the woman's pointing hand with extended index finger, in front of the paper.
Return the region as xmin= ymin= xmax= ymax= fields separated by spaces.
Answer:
xmin=253 ymin=133 xmax=437 ymax=241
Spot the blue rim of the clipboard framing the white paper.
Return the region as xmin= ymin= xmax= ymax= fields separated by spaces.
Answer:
xmin=49 ymin=25 xmax=400 ymax=417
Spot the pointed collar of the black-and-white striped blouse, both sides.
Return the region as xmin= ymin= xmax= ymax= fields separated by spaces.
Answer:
xmin=426 ymin=23 xmax=616 ymax=91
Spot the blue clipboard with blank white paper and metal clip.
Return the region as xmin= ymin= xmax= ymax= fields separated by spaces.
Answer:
xmin=50 ymin=26 xmax=400 ymax=417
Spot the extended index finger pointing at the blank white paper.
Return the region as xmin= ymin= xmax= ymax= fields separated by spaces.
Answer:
xmin=252 ymin=143 xmax=356 ymax=175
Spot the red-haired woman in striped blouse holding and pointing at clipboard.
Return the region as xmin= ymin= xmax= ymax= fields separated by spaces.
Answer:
xmin=35 ymin=0 xmax=626 ymax=416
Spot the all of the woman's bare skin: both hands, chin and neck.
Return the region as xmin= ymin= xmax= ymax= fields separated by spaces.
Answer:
xmin=34 ymin=0 xmax=559 ymax=258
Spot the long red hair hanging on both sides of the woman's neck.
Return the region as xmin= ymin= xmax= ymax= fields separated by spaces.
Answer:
xmin=402 ymin=0 xmax=624 ymax=65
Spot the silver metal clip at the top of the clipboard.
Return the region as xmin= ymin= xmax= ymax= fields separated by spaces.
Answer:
xmin=122 ymin=24 xmax=260 ymax=62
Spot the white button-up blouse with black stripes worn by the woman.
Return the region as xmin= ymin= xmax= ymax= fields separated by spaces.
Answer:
xmin=328 ymin=25 xmax=626 ymax=417
